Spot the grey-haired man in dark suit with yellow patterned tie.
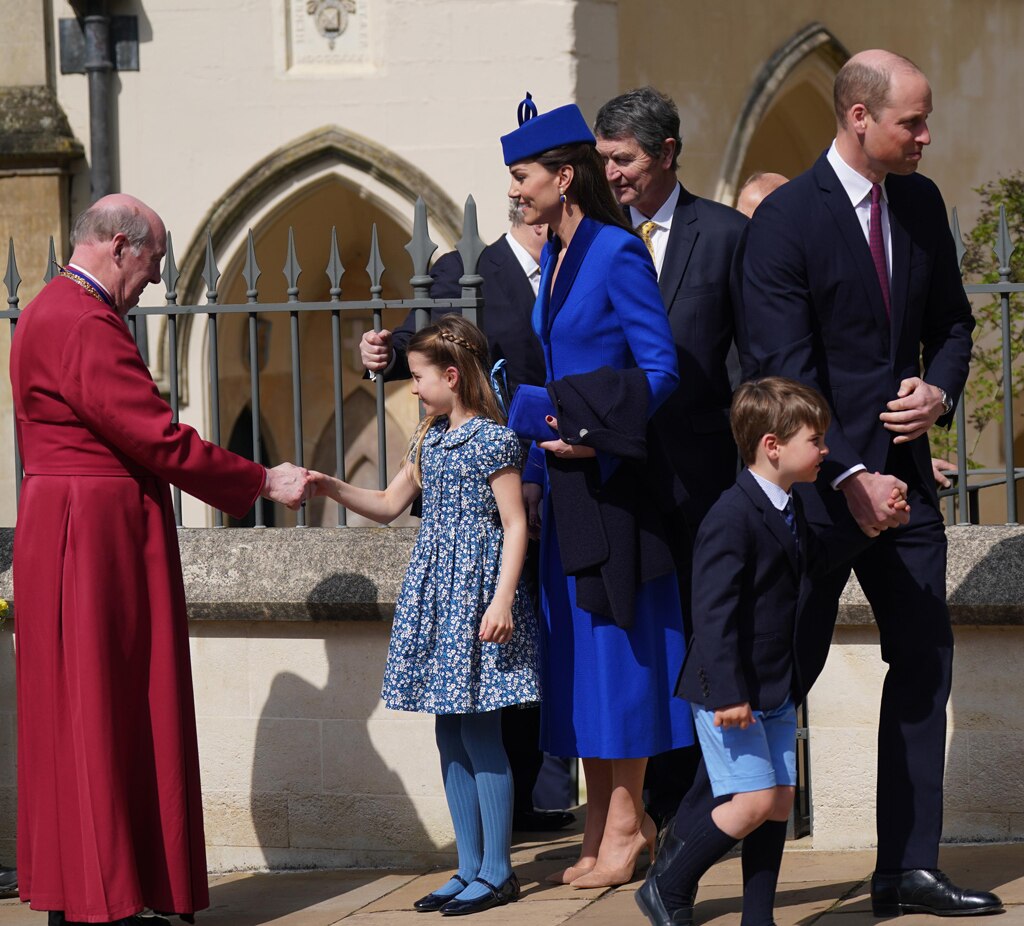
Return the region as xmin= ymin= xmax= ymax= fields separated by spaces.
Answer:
xmin=594 ymin=87 xmax=746 ymax=820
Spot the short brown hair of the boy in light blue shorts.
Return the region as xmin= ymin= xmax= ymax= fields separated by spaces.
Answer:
xmin=729 ymin=376 xmax=831 ymax=466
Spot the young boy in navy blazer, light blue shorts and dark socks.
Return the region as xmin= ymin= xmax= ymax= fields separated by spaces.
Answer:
xmin=636 ymin=377 xmax=907 ymax=926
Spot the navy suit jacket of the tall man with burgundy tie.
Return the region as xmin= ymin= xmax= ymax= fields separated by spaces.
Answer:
xmin=742 ymin=155 xmax=974 ymax=510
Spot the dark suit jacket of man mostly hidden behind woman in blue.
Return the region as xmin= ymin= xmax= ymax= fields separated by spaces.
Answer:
xmin=386 ymin=235 xmax=545 ymax=394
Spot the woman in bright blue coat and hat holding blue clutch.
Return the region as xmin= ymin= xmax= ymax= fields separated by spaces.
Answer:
xmin=502 ymin=94 xmax=693 ymax=888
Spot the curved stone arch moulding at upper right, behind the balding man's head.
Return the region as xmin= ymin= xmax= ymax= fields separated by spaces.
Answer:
xmin=715 ymin=23 xmax=850 ymax=205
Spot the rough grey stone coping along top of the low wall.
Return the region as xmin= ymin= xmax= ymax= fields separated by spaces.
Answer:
xmin=0 ymin=525 xmax=1024 ymax=627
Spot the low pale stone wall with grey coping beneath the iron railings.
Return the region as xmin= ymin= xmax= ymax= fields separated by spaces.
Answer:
xmin=0 ymin=528 xmax=1024 ymax=871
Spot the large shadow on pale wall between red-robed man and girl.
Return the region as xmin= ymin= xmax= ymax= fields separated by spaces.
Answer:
xmin=251 ymin=573 xmax=450 ymax=869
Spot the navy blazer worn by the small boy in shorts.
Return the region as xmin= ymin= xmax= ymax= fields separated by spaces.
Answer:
xmin=676 ymin=469 xmax=818 ymax=710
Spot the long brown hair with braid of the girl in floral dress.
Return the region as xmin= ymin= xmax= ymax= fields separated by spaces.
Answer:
xmin=406 ymin=314 xmax=505 ymax=489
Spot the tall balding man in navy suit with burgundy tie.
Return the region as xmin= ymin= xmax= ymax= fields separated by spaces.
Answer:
xmin=742 ymin=50 xmax=1001 ymax=916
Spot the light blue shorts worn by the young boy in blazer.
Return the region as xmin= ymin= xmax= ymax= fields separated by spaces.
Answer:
xmin=690 ymin=698 xmax=797 ymax=797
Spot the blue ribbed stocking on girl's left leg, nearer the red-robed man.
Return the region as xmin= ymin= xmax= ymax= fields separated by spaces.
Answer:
xmin=434 ymin=714 xmax=483 ymax=897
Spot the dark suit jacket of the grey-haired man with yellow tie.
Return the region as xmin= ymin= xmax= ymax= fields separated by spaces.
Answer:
xmin=653 ymin=185 xmax=746 ymax=538
